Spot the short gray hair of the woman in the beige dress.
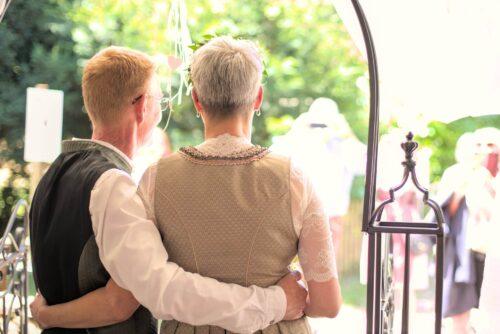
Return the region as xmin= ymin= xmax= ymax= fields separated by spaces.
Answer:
xmin=190 ymin=37 xmax=262 ymax=117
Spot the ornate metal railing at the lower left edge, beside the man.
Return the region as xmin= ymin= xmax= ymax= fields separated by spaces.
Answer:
xmin=0 ymin=200 xmax=28 ymax=334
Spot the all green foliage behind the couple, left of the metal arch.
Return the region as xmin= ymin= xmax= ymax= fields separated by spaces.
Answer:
xmin=0 ymin=0 xmax=367 ymax=153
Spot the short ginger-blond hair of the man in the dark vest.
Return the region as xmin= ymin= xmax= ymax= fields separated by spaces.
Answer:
xmin=82 ymin=46 xmax=156 ymax=125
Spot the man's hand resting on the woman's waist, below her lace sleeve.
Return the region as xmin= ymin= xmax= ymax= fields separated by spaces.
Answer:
xmin=278 ymin=271 xmax=307 ymax=320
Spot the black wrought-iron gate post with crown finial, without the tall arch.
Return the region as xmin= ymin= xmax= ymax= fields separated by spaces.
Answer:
xmin=368 ymin=132 xmax=444 ymax=333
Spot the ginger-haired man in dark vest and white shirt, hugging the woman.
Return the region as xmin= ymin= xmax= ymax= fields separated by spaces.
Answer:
xmin=30 ymin=47 xmax=307 ymax=333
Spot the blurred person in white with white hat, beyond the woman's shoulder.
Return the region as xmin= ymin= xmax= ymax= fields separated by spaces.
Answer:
xmin=271 ymin=97 xmax=366 ymax=250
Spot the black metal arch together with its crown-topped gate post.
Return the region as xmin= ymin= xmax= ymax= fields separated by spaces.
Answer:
xmin=351 ymin=0 xmax=444 ymax=334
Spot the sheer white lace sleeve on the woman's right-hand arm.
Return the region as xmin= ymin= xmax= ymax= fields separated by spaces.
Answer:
xmin=290 ymin=160 xmax=338 ymax=282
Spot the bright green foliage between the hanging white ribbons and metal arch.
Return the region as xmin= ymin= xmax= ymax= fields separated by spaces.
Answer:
xmin=182 ymin=0 xmax=366 ymax=145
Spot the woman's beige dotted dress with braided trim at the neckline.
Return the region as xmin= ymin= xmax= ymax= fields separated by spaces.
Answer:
xmin=142 ymin=134 xmax=337 ymax=334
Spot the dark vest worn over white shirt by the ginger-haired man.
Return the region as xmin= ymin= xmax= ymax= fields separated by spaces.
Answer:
xmin=30 ymin=140 xmax=156 ymax=334
